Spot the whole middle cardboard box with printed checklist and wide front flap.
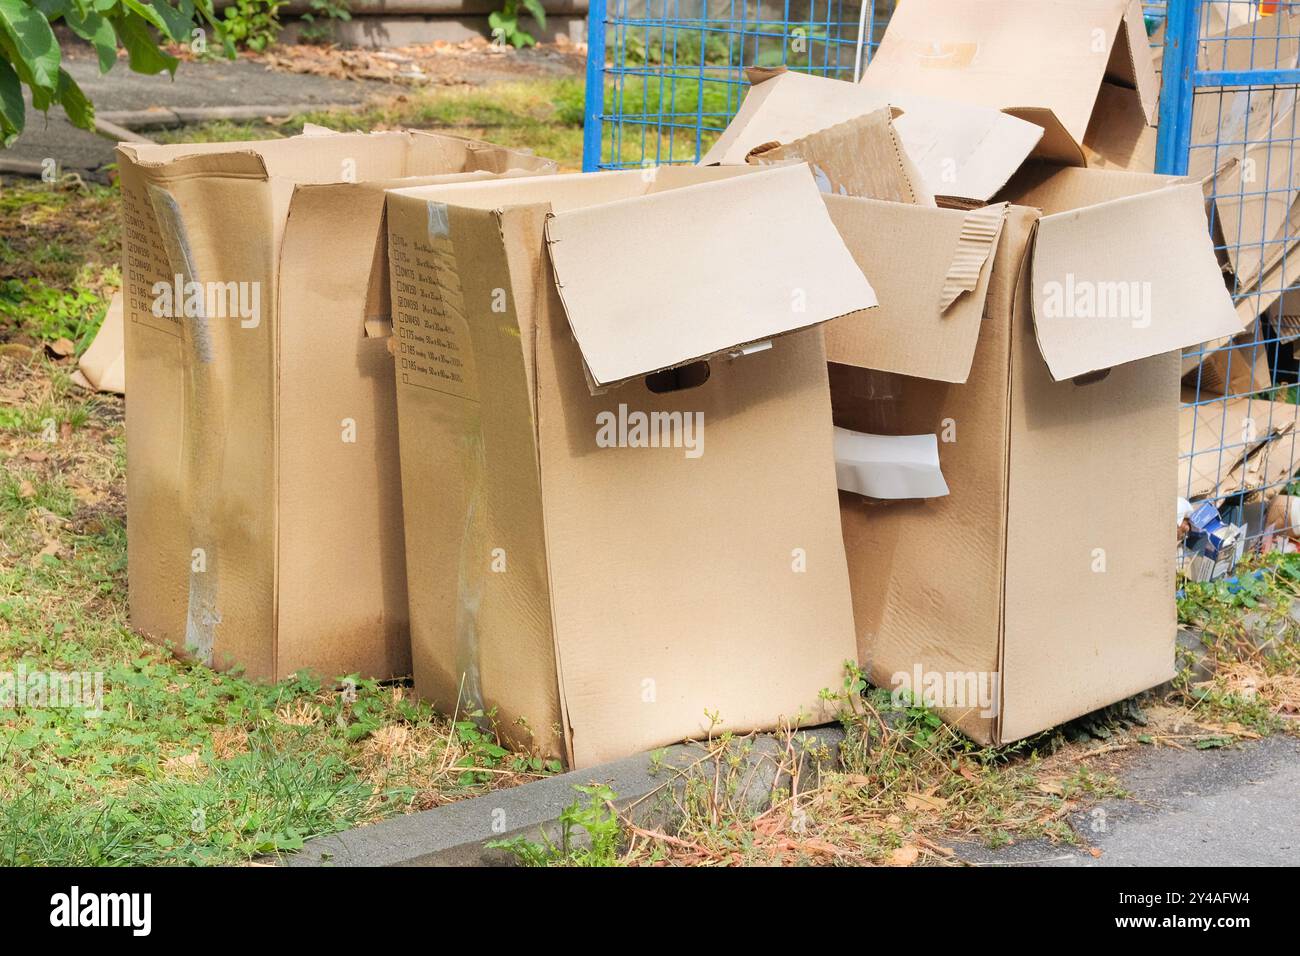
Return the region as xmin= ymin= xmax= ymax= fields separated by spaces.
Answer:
xmin=387 ymin=165 xmax=875 ymax=767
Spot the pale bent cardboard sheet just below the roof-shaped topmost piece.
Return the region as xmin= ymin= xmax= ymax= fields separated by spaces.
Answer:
xmin=701 ymin=70 xmax=1043 ymax=202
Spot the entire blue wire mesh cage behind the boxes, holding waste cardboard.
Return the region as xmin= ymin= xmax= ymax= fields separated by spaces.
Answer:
xmin=582 ymin=0 xmax=1300 ymax=550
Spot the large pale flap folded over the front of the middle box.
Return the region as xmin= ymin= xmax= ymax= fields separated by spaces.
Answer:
xmin=546 ymin=165 xmax=876 ymax=386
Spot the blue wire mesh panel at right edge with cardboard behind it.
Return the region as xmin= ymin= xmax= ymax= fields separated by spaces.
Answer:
xmin=1161 ymin=0 xmax=1300 ymax=561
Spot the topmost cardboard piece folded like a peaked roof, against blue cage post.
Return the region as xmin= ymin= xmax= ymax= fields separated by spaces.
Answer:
xmin=862 ymin=0 xmax=1160 ymax=165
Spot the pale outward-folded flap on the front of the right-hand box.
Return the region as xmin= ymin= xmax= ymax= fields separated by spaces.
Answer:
xmin=1030 ymin=180 xmax=1242 ymax=381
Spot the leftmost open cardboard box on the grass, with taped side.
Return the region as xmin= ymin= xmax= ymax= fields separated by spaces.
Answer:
xmin=118 ymin=129 xmax=555 ymax=680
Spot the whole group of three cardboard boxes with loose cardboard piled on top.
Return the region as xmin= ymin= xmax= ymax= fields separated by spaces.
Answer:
xmin=122 ymin=0 xmax=1258 ymax=766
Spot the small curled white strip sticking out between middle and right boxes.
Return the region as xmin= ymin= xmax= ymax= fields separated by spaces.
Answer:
xmin=835 ymin=428 xmax=948 ymax=498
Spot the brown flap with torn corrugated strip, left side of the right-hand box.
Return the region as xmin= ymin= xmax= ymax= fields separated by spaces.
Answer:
xmin=824 ymin=196 xmax=1006 ymax=382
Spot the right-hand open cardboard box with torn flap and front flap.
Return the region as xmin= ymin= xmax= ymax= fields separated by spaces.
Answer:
xmin=826 ymin=166 xmax=1240 ymax=744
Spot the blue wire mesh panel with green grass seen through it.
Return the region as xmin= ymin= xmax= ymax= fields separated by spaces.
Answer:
xmin=584 ymin=0 xmax=894 ymax=170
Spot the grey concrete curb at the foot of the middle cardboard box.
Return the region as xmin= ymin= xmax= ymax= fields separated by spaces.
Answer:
xmin=280 ymin=726 xmax=844 ymax=866
